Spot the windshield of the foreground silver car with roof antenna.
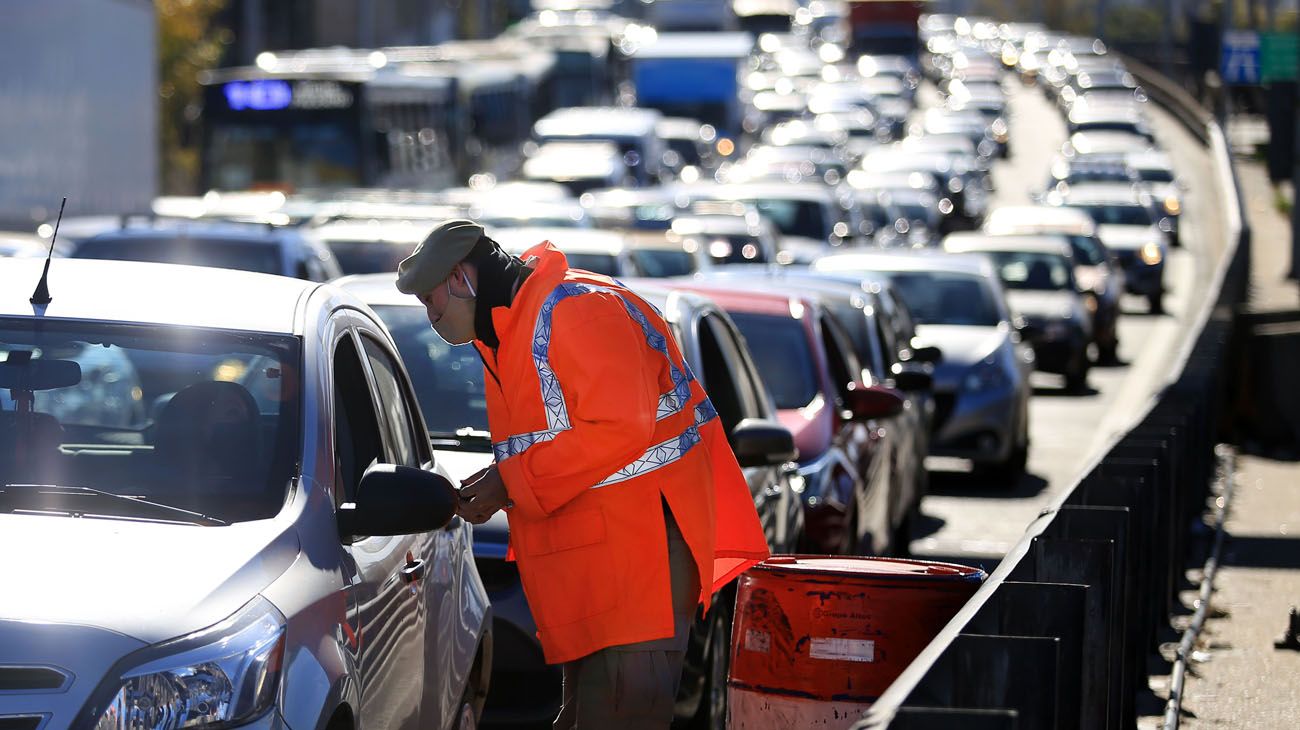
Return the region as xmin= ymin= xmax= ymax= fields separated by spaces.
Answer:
xmin=0 ymin=320 xmax=302 ymax=523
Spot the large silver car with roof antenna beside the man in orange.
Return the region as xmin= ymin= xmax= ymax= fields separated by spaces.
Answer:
xmin=0 ymin=258 xmax=491 ymax=730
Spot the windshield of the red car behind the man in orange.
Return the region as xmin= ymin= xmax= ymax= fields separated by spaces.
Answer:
xmin=731 ymin=312 xmax=819 ymax=410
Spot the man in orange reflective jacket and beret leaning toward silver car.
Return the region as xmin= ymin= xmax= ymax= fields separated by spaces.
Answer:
xmin=398 ymin=221 xmax=768 ymax=730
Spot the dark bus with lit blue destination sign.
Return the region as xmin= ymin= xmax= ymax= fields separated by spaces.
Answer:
xmin=199 ymin=49 xmax=471 ymax=191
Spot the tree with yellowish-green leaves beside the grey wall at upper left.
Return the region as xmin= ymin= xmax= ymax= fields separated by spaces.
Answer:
xmin=155 ymin=0 xmax=234 ymax=194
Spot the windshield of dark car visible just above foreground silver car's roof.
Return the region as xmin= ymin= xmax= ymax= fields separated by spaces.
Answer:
xmin=73 ymin=235 xmax=285 ymax=274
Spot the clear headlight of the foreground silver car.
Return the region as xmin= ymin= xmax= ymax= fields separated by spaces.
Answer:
xmin=95 ymin=596 xmax=285 ymax=730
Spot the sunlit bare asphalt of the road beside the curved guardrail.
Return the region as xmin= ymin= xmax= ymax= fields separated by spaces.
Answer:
xmin=911 ymin=79 xmax=1223 ymax=558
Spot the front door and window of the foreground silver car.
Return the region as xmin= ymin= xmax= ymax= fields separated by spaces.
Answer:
xmin=332 ymin=324 xmax=430 ymax=729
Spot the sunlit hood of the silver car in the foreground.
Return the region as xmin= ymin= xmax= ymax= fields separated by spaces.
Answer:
xmin=0 ymin=514 xmax=299 ymax=643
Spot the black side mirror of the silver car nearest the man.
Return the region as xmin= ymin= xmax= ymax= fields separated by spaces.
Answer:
xmin=338 ymin=464 xmax=459 ymax=539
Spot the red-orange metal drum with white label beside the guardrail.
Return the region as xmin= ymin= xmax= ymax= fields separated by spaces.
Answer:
xmin=727 ymin=556 xmax=985 ymax=730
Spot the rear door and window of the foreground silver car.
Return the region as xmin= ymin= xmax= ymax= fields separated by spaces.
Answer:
xmin=360 ymin=323 xmax=476 ymax=727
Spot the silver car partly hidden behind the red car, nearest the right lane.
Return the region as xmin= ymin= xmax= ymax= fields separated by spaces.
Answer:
xmin=813 ymin=249 xmax=1035 ymax=482
